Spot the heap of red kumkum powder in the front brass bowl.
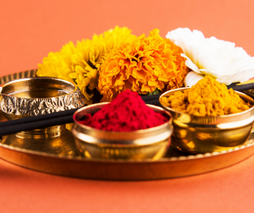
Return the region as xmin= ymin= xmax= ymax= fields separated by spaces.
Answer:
xmin=79 ymin=90 xmax=168 ymax=132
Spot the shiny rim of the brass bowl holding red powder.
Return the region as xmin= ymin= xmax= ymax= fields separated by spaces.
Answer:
xmin=73 ymin=102 xmax=173 ymax=135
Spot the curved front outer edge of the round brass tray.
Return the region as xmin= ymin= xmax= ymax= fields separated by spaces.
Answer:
xmin=0 ymin=133 xmax=254 ymax=181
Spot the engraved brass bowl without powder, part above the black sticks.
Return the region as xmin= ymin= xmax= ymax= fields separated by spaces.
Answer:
xmin=0 ymin=77 xmax=85 ymax=120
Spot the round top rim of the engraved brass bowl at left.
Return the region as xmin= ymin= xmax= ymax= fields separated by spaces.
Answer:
xmin=0 ymin=76 xmax=78 ymax=100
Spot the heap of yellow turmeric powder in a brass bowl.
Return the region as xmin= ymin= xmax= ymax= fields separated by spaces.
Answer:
xmin=161 ymin=76 xmax=251 ymax=116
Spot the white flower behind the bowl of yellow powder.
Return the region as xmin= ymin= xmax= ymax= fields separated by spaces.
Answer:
xmin=166 ymin=28 xmax=254 ymax=86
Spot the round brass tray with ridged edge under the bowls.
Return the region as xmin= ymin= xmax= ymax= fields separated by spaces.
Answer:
xmin=0 ymin=70 xmax=254 ymax=180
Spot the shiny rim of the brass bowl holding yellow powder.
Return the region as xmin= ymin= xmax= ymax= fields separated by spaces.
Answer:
xmin=159 ymin=87 xmax=254 ymax=123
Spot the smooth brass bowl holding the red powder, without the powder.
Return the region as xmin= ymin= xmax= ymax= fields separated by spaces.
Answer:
xmin=72 ymin=103 xmax=173 ymax=160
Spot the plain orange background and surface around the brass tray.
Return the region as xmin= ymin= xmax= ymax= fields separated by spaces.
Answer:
xmin=0 ymin=0 xmax=254 ymax=213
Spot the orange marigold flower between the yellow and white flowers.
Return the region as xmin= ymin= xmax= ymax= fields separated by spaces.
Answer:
xmin=98 ymin=29 xmax=188 ymax=101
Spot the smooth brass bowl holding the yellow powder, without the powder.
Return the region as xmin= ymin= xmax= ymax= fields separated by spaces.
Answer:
xmin=159 ymin=88 xmax=254 ymax=154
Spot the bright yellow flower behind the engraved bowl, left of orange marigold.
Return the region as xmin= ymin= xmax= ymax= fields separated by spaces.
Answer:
xmin=37 ymin=27 xmax=136 ymax=103
